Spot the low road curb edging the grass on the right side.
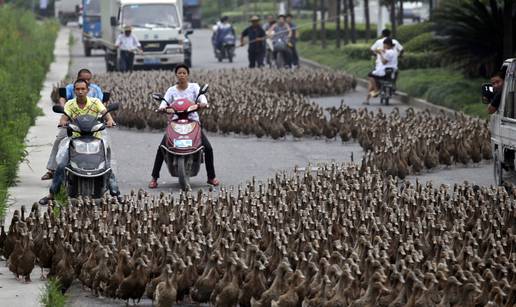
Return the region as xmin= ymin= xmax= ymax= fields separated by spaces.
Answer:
xmin=300 ymin=58 xmax=459 ymax=116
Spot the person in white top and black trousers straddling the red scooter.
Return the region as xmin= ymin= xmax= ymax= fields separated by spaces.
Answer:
xmin=149 ymin=64 xmax=220 ymax=189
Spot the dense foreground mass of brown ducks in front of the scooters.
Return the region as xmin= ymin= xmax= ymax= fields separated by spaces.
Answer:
xmin=0 ymin=163 xmax=516 ymax=307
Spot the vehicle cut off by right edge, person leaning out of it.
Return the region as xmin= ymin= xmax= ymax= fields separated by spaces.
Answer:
xmin=483 ymin=58 xmax=516 ymax=185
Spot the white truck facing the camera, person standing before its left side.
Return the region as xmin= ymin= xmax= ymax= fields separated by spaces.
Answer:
xmin=101 ymin=0 xmax=192 ymax=71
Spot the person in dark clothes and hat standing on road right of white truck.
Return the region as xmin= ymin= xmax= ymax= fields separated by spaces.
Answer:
xmin=240 ymin=16 xmax=266 ymax=68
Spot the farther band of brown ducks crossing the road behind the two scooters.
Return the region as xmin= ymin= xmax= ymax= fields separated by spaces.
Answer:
xmin=81 ymin=69 xmax=491 ymax=178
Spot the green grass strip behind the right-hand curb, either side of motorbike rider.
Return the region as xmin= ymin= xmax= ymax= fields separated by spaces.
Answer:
xmin=297 ymin=41 xmax=487 ymax=118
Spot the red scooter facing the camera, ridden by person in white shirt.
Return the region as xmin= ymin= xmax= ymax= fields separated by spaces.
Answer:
xmin=151 ymin=84 xmax=208 ymax=191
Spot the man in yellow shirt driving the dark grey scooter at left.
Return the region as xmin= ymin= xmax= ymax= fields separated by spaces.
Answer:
xmin=39 ymin=79 xmax=120 ymax=205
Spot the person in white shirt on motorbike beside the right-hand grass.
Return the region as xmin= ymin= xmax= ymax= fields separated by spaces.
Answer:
xmin=364 ymin=38 xmax=398 ymax=104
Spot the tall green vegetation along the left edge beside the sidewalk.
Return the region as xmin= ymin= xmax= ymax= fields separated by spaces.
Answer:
xmin=0 ymin=5 xmax=59 ymax=216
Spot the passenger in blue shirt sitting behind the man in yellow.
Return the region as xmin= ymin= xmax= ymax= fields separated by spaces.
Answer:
xmin=41 ymin=68 xmax=104 ymax=180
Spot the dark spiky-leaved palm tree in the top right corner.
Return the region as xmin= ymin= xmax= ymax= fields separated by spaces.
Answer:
xmin=434 ymin=0 xmax=516 ymax=77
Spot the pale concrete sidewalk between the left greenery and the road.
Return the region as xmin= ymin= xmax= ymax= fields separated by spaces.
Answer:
xmin=0 ymin=27 xmax=70 ymax=307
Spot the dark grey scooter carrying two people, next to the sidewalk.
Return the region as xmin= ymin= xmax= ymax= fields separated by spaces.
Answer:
xmin=52 ymin=103 xmax=119 ymax=198
